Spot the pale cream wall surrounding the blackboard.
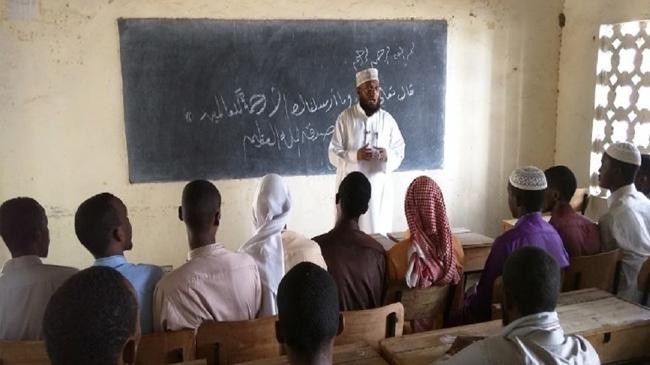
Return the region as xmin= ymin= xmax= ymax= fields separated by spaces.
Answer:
xmin=0 ymin=0 xmax=560 ymax=267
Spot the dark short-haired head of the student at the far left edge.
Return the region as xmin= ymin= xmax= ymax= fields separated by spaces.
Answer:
xmin=0 ymin=197 xmax=50 ymax=257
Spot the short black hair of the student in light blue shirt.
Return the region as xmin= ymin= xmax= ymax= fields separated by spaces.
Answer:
xmin=74 ymin=193 xmax=123 ymax=257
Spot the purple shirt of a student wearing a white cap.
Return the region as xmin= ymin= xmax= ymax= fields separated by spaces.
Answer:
xmin=463 ymin=212 xmax=569 ymax=323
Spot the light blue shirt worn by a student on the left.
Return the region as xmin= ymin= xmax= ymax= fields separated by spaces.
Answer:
xmin=93 ymin=255 xmax=163 ymax=334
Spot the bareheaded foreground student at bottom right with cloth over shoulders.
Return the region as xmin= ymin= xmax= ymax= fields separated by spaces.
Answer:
xmin=442 ymin=247 xmax=600 ymax=365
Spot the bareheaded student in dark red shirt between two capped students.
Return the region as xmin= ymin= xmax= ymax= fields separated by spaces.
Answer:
xmin=544 ymin=166 xmax=600 ymax=257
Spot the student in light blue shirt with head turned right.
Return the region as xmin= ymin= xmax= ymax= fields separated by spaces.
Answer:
xmin=74 ymin=193 xmax=163 ymax=334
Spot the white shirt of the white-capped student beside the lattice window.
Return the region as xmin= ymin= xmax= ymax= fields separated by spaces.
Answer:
xmin=598 ymin=184 xmax=650 ymax=303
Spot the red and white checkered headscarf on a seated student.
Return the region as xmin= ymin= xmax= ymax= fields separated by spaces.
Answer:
xmin=404 ymin=176 xmax=460 ymax=288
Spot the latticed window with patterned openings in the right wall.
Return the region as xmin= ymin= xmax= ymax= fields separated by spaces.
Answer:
xmin=590 ymin=20 xmax=650 ymax=195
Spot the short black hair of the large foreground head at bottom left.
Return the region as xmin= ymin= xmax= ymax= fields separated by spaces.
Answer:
xmin=43 ymin=266 xmax=138 ymax=365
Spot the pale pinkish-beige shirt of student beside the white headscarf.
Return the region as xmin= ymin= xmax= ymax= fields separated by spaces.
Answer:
xmin=153 ymin=243 xmax=262 ymax=331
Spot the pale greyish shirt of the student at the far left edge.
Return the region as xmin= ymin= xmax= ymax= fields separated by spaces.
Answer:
xmin=0 ymin=256 xmax=77 ymax=341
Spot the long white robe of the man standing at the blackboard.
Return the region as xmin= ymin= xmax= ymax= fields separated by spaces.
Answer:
xmin=328 ymin=104 xmax=405 ymax=233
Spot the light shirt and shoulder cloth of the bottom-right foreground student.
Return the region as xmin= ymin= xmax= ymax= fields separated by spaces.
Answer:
xmin=439 ymin=312 xmax=600 ymax=365
